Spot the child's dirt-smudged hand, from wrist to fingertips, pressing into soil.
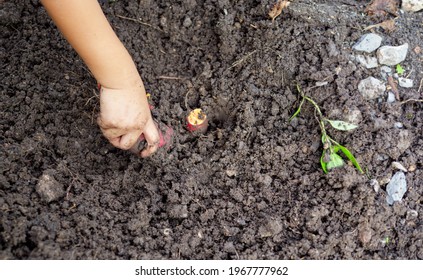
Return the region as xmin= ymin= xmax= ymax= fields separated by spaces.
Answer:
xmin=98 ymin=84 xmax=160 ymax=157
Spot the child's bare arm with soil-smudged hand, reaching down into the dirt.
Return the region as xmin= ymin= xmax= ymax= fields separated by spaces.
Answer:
xmin=41 ymin=0 xmax=159 ymax=156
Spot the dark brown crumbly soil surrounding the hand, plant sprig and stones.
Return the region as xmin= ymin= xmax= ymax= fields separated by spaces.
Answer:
xmin=0 ymin=0 xmax=423 ymax=259
